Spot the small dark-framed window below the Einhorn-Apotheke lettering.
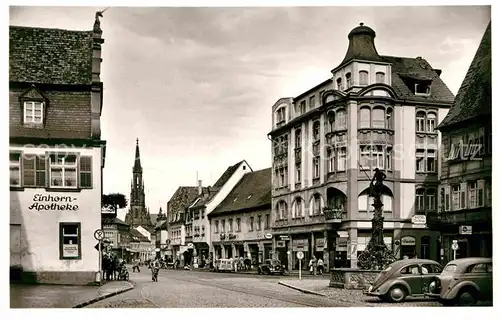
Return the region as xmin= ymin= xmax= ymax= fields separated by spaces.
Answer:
xmin=59 ymin=222 xmax=82 ymax=260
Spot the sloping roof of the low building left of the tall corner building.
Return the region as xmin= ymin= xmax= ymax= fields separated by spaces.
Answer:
xmin=209 ymin=168 xmax=271 ymax=216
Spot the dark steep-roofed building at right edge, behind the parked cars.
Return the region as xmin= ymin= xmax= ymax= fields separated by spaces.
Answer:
xmin=429 ymin=23 xmax=493 ymax=262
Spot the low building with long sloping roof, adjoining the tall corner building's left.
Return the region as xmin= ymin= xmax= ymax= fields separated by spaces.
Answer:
xmin=208 ymin=168 xmax=274 ymax=265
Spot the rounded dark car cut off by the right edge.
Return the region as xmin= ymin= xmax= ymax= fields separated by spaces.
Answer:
xmin=427 ymin=258 xmax=493 ymax=306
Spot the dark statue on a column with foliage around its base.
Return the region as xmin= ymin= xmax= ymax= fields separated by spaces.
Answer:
xmin=358 ymin=168 xmax=395 ymax=270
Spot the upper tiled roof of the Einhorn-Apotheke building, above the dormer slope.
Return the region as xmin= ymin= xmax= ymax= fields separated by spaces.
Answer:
xmin=9 ymin=26 xmax=93 ymax=85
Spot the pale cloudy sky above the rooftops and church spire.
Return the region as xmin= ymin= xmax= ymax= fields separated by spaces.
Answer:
xmin=9 ymin=6 xmax=490 ymax=218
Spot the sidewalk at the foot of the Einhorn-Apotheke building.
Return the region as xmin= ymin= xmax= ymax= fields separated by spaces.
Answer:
xmin=10 ymin=281 xmax=134 ymax=308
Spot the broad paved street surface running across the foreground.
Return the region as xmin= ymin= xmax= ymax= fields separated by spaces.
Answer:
xmin=88 ymin=268 xmax=454 ymax=308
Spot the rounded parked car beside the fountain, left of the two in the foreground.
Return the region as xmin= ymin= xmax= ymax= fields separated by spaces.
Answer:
xmin=365 ymin=259 xmax=443 ymax=302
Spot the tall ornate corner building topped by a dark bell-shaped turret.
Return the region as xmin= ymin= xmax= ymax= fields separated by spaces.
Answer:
xmin=269 ymin=24 xmax=454 ymax=268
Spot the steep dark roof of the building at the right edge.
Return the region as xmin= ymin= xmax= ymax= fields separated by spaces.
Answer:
xmin=438 ymin=22 xmax=492 ymax=130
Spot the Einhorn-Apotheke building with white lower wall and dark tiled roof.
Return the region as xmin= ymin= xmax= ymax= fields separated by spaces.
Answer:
xmin=9 ymin=18 xmax=105 ymax=284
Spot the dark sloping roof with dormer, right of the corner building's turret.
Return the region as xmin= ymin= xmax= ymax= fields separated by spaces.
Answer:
xmin=382 ymin=56 xmax=455 ymax=103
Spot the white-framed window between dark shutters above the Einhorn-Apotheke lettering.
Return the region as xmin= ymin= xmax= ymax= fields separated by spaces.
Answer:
xmin=49 ymin=154 xmax=78 ymax=188
